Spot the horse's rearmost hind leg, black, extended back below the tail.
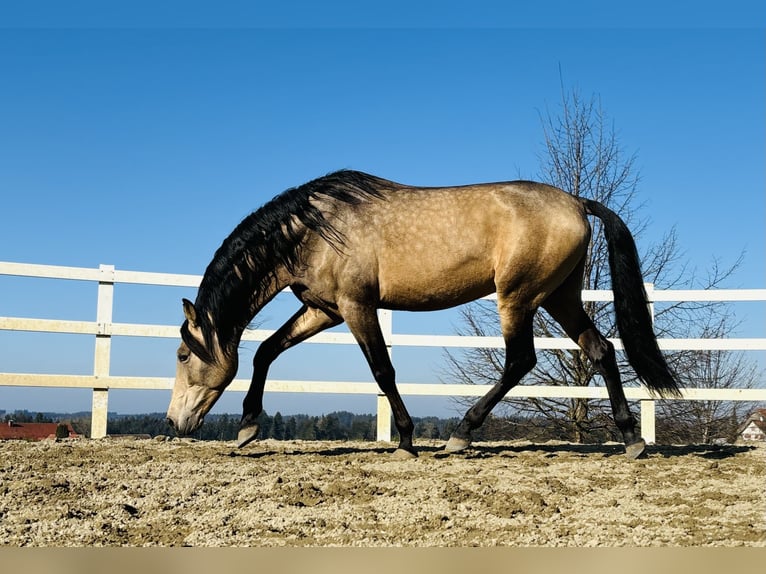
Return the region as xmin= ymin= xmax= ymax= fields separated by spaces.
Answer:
xmin=543 ymin=286 xmax=646 ymax=459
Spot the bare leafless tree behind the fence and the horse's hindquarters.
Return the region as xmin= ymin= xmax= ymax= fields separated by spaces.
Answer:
xmin=447 ymin=86 xmax=750 ymax=442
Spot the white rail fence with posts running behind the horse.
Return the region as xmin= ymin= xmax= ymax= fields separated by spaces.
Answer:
xmin=0 ymin=262 xmax=766 ymax=443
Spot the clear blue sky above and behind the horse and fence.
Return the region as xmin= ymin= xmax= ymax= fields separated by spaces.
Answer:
xmin=0 ymin=2 xmax=766 ymax=414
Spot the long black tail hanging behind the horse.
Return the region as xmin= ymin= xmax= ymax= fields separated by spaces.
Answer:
xmin=580 ymin=198 xmax=681 ymax=397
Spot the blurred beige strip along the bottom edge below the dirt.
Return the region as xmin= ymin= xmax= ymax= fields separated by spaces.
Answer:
xmin=0 ymin=547 xmax=766 ymax=574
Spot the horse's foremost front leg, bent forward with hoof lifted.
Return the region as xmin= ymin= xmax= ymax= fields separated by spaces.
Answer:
xmin=237 ymin=305 xmax=341 ymax=448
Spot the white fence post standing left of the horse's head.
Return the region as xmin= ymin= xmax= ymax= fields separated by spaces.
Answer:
xmin=90 ymin=265 xmax=114 ymax=438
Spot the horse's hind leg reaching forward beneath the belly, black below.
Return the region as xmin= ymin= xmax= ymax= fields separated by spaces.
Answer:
xmin=445 ymin=308 xmax=537 ymax=452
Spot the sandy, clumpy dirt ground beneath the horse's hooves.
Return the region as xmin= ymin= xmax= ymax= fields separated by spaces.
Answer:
xmin=0 ymin=437 xmax=766 ymax=547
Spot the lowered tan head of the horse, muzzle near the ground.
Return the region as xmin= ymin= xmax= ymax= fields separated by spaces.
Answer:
xmin=167 ymin=299 xmax=238 ymax=436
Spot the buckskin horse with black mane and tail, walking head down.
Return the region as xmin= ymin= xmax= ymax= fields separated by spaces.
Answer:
xmin=167 ymin=170 xmax=680 ymax=459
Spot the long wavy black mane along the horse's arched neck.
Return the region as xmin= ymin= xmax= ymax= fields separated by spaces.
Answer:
xmin=181 ymin=170 xmax=393 ymax=362
